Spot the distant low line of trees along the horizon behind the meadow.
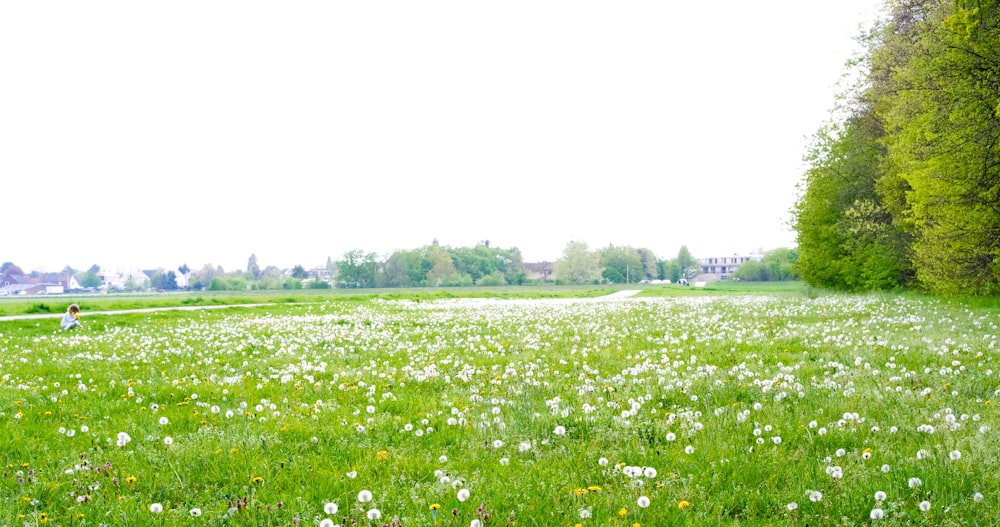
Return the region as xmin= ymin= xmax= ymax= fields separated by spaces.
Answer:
xmin=0 ymin=240 xmax=798 ymax=291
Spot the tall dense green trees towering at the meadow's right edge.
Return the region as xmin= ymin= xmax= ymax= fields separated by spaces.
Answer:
xmin=793 ymin=0 xmax=1000 ymax=295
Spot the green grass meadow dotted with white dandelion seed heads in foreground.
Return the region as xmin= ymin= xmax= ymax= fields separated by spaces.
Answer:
xmin=0 ymin=295 xmax=1000 ymax=527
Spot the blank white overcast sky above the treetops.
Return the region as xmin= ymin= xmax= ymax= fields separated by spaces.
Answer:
xmin=0 ymin=0 xmax=881 ymax=271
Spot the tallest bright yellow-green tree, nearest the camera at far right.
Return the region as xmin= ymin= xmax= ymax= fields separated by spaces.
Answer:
xmin=874 ymin=0 xmax=1000 ymax=294
